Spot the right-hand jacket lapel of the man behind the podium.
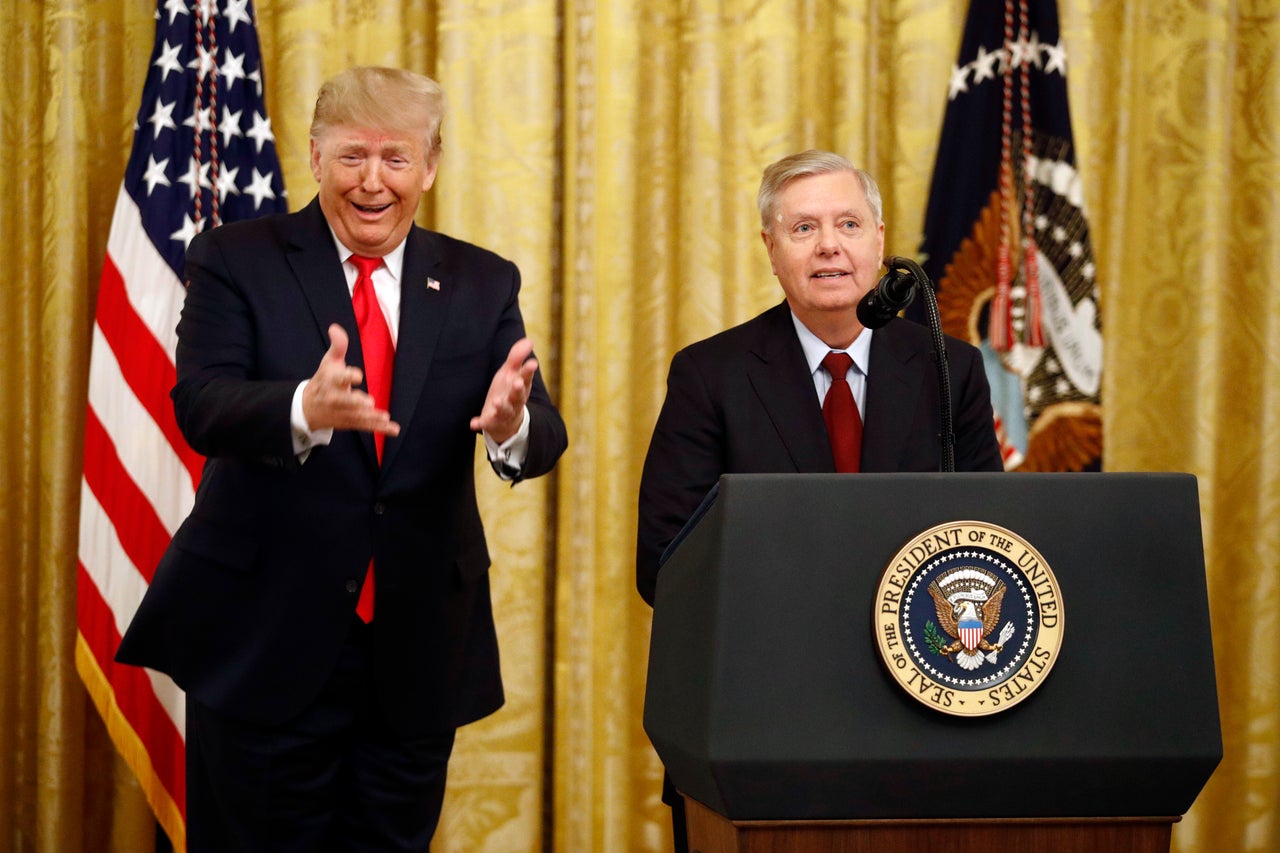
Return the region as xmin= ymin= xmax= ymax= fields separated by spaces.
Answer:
xmin=863 ymin=320 xmax=933 ymax=471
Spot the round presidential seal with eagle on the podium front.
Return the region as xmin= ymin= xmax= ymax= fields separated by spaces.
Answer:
xmin=872 ymin=521 xmax=1064 ymax=716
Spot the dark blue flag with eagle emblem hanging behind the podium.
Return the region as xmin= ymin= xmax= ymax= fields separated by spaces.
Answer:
xmin=920 ymin=0 xmax=1102 ymax=471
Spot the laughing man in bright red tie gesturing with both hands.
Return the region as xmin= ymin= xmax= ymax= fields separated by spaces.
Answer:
xmin=118 ymin=68 xmax=567 ymax=853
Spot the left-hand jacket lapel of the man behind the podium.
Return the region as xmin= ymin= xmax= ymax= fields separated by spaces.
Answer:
xmin=748 ymin=302 xmax=836 ymax=474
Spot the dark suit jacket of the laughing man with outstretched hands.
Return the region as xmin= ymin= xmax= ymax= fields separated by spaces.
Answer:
xmin=116 ymin=195 xmax=567 ymax=735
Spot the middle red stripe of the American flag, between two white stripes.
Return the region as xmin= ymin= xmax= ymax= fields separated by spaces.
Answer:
xmin=84 ymin=406 xmax=169 ymax=584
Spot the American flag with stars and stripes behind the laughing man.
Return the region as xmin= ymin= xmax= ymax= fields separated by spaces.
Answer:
xmin=76 ymin=0 xmax=285 ymax=850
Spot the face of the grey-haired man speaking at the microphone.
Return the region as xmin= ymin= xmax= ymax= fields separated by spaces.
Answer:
xmin=762 ymin=172 xmax=884 ymax=329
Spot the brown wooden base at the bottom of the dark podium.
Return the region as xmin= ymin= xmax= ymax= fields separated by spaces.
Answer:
xmin=685 ymin=797 xmax=1180 ymax=853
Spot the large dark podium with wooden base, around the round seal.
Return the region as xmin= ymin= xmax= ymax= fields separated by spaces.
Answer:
xmin=644 ymin=474 xmax=1222 ymax=853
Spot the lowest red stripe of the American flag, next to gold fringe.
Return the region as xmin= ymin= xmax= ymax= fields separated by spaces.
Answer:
xmin=77 ymin=564 xmax=187 ymax=818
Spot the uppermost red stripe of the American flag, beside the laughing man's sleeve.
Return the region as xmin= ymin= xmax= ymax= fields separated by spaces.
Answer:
xmin=97 ymin=255 xmax=205 ymax=488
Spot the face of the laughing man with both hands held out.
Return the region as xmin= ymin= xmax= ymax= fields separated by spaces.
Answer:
xmin=311 ymin=127 xmax=436 ymax=257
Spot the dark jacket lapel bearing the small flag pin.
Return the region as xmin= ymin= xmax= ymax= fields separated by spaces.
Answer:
xmin=383 ymin=225 xmax=456 ymax=473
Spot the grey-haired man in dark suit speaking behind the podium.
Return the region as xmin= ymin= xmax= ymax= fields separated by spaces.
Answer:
xmin=636 ymin=151 xmax=1002 ymax=850
